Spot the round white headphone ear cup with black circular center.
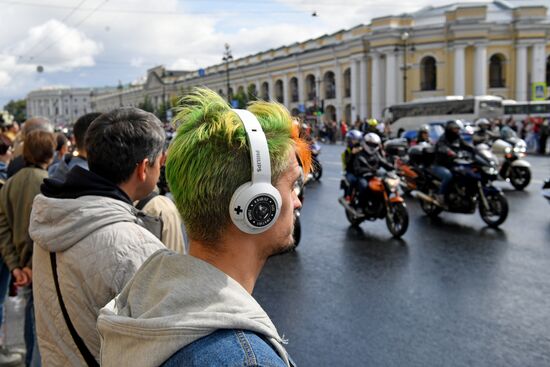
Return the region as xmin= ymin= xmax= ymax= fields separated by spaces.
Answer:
xmin=229 ymin=182 xmax=282 ymax=234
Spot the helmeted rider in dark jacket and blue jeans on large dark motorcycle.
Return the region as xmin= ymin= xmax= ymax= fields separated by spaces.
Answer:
xmin=432 ymin=120 xmax=475 ymax=206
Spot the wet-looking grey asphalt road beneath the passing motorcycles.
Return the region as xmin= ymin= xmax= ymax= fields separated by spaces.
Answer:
xmin=254 ymin=145 xmax=550 ymax=367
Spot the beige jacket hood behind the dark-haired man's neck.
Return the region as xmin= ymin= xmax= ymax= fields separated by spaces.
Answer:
xmin=29 ymin=194 xmax=141 ymax=252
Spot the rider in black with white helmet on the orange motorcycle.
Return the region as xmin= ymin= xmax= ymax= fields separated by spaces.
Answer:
xmin=353 ymin=133 xmax=394 ymax=212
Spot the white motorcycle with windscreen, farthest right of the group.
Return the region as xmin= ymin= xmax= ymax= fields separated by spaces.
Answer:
xmin=476 ymin=137 xmax=531 ymax=190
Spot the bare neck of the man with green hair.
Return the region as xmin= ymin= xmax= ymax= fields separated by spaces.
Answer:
xmin=189 ymin=230 xmax=267 ymax=294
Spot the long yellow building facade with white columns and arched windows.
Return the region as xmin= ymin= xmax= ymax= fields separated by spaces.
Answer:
xmin=95 ymin=0 xmax=550 ymax=122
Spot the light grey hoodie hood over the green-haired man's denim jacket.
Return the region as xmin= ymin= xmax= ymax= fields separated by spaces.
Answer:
xmin=98 ymin=250 xmax=290 ymax=367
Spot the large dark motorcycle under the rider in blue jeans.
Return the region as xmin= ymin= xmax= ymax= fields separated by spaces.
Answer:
xmin=411 ymin=151 xmax=508 ymax=227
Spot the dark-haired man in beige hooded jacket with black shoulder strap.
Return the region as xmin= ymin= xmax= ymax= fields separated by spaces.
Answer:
xmin=29 ymin=108 xmax=165 ymax=366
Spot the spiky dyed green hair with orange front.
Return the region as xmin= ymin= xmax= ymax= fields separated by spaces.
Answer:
xmin=166 ymin=88 xmax=311 ymax=244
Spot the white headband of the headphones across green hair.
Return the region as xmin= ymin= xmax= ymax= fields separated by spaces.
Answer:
xmin=232 ymin=109 xmax=271 ymax=184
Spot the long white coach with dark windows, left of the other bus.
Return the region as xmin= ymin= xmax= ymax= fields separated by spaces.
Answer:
xmin=383 ymin=96 xmax=504 ymax=131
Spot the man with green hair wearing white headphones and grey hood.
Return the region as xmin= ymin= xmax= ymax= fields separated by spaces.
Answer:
xmin=98 ymin=89 xmax=311 ymax=366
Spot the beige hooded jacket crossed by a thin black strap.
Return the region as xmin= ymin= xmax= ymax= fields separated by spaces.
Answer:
xmin=29 ymin=195 xmax=164 ymax=366
